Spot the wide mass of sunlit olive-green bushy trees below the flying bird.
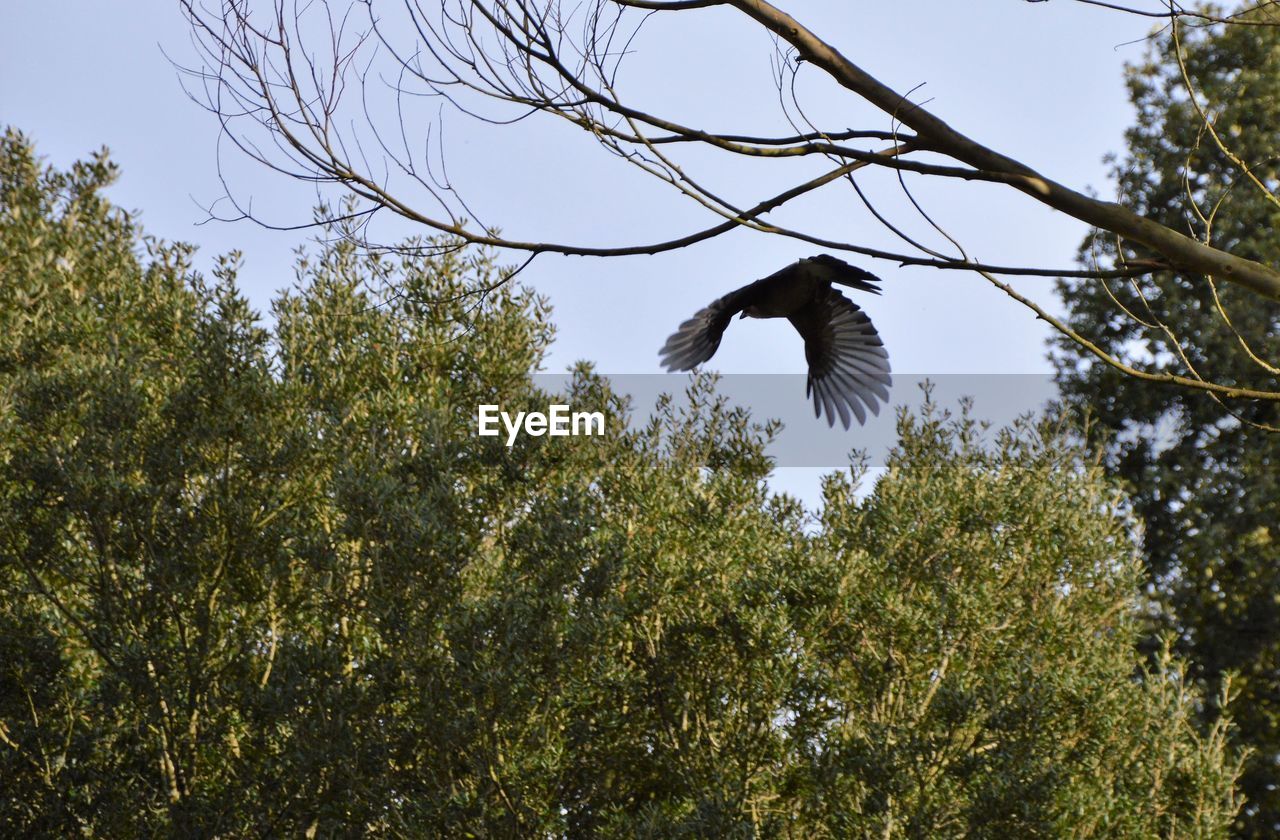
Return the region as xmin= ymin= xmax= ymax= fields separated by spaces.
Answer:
xmin=0 ymin=132 xmax=1239 ymax=837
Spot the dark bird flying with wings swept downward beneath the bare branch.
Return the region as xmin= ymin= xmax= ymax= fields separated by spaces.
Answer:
xmin=658 ymin=254 xmax=893 ymax=430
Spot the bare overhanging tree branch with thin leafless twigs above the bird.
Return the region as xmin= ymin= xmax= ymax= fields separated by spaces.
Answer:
xmin=180 ymin=0 xmax=1280 ymax=402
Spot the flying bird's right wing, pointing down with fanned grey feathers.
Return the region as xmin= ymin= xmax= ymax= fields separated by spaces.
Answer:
xmin=788 ymin=288 xmax=893 ymax=429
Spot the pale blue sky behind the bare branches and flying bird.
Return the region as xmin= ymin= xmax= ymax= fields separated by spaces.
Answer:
xmin=0 ymin=0 xmax=1149 ymax=496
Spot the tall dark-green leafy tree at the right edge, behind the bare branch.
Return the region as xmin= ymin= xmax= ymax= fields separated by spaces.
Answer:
xmin=1059 ymin=13 xmax=1280 ymax=837
